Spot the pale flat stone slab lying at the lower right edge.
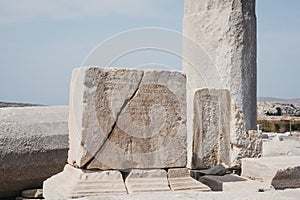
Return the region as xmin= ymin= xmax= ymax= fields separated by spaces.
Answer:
xmin=242 ymin=156 xmax=300 ymax=189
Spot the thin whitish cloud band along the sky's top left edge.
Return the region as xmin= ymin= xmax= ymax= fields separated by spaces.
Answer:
xmin=0 ymin=0 xmax=158 ymax=24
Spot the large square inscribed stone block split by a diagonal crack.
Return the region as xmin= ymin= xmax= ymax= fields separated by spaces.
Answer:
xmin=68 ymin=67 xmax=186 ymax=169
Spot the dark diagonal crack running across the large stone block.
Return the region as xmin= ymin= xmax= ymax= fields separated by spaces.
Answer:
xmin=83 ymin=71 xmax=144 ymax=169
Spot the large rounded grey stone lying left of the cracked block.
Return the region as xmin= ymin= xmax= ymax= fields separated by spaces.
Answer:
xmin=0 ymin=106 xmax=68 ymax=198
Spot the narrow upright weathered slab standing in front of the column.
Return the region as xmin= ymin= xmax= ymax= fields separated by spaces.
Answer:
xmin=191 ymin=89 xmax=231 ymax=169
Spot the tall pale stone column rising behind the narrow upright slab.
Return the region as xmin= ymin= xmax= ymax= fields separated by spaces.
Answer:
xmin=183 ymin=0 xmax=257 ymax=167
